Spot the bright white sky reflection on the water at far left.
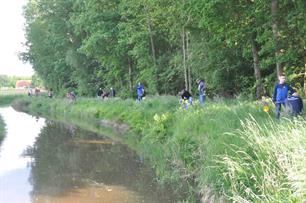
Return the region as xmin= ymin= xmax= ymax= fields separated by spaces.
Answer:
xmin=0 ymin=107 xmax=45 ymax=203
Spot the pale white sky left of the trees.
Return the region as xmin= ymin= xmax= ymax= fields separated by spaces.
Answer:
xmin=0 ymin=0 xmax=34 ymax=76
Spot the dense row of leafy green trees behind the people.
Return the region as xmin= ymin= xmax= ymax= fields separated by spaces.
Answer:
xmin=22 ymin=0 xmax=306 ymax=97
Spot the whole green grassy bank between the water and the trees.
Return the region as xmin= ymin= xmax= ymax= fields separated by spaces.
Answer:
xmin=15 ymin=97 xmax=306 ymax=202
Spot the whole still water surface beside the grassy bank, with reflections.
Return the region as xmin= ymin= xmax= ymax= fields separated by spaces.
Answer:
xmin=0 ymin=107 xmax=177 ymax=203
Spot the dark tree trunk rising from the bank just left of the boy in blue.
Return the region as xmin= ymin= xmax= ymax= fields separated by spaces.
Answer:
xmin=251 ymin=35 xmax=263 ymax=99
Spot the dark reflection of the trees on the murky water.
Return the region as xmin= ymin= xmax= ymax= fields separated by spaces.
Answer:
xmin=24 ymin=121 xmax=176 ymax=202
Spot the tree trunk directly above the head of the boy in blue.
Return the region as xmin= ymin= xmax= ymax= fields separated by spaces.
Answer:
xmin=271 ymin=0 xmax=283 ymax=77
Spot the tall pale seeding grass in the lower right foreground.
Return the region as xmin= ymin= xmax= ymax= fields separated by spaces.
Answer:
xmin=218 ymin=118 xmax=306 ymax=202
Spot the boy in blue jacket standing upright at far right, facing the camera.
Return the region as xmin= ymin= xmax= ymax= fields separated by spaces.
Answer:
xmin=272 ymin=75 xmax=295 ymax=119
